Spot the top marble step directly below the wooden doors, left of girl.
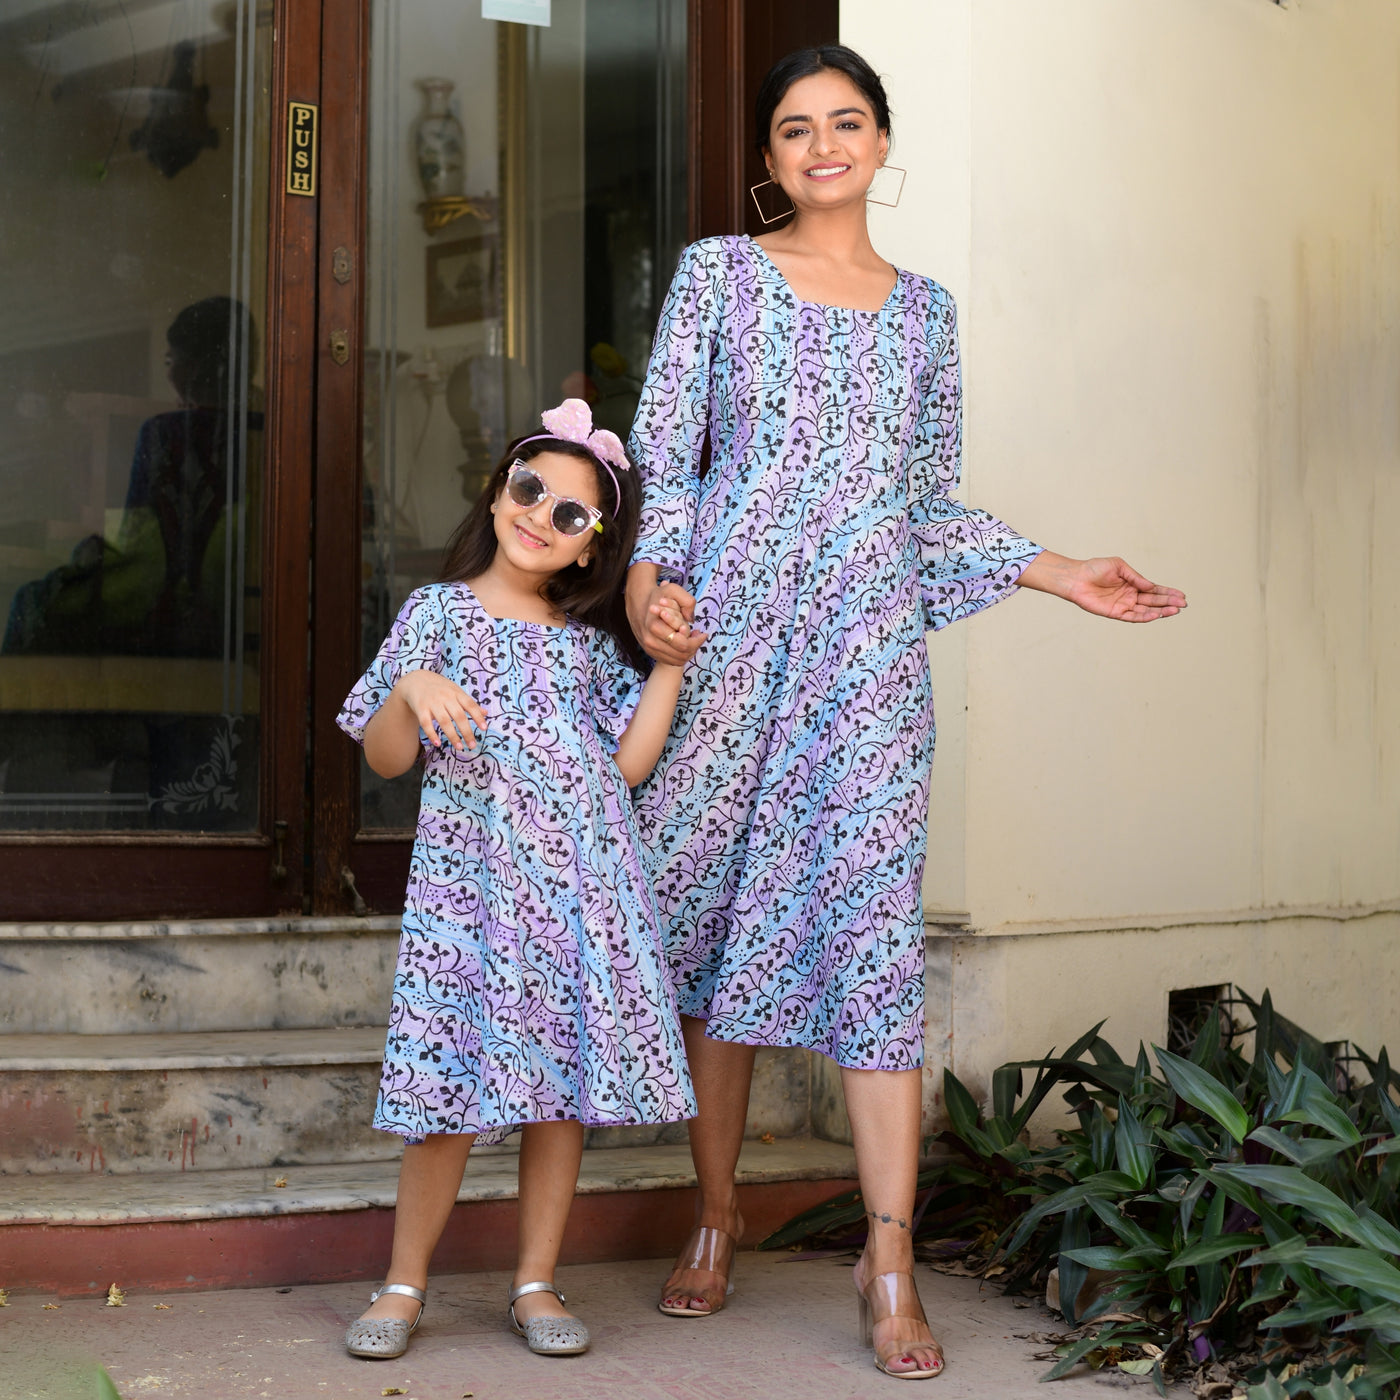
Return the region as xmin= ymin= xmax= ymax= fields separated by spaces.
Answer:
xmin=0 ymin=917 xmax=399 ymax=1035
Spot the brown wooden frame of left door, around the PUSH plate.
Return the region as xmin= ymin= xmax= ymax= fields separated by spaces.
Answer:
xmin=0 ymin=0 xmax=321 ymax=921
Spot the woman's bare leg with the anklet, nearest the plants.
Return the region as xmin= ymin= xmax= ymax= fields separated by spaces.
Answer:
xmin=841 ymin=1068 xmax=944 ymax=1371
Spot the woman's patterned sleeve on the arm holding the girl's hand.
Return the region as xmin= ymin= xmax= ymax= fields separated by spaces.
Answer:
xmin=627 ymin=244 xmax=718 ymax=577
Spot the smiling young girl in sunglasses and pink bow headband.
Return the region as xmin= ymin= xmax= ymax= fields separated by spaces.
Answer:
xmin=337 ymin=399 xmax=703 ymax=1358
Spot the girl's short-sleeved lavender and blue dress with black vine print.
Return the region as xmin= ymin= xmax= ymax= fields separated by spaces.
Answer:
xmin=336 ymin=584 xmax=696 ymax=1144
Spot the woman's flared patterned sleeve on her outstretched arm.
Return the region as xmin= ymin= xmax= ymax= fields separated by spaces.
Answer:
xmin=907 ymin=287 xmax=1040 ymax=631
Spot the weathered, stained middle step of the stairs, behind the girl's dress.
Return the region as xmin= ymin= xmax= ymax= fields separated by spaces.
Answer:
xmin=0 ymin=1026 xmax=812 ymax=1175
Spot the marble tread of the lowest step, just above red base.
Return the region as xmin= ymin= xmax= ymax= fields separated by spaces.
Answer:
xmin=0 ymin=1138 xmax=855 ymax=1228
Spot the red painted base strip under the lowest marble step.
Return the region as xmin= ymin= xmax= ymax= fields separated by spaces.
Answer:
xmin=0 ymin=1180 xmax=855 ymax=1296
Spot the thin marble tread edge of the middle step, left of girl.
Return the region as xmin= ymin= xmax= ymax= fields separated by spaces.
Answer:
xmin=0 ymin=1026 xmax=385 ymax=1074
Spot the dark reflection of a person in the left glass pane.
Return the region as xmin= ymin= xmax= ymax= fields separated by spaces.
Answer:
xmin=117 ymin=297 xmax=262 ymax=657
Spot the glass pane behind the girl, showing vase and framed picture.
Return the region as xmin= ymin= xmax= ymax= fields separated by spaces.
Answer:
xmin=360 ymin=0 xmax=686 ymax=830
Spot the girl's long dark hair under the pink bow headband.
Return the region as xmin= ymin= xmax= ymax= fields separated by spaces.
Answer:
xmin=438 ymin=434 xmax=648 ymax=671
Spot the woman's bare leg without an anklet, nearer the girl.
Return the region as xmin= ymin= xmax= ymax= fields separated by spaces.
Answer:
xmin=662 ymin=1016 xmax=756 ymax=1312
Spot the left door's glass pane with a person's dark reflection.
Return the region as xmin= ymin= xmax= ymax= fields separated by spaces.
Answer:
xmin=0 ymin=0 xmax=270 ymax=830
